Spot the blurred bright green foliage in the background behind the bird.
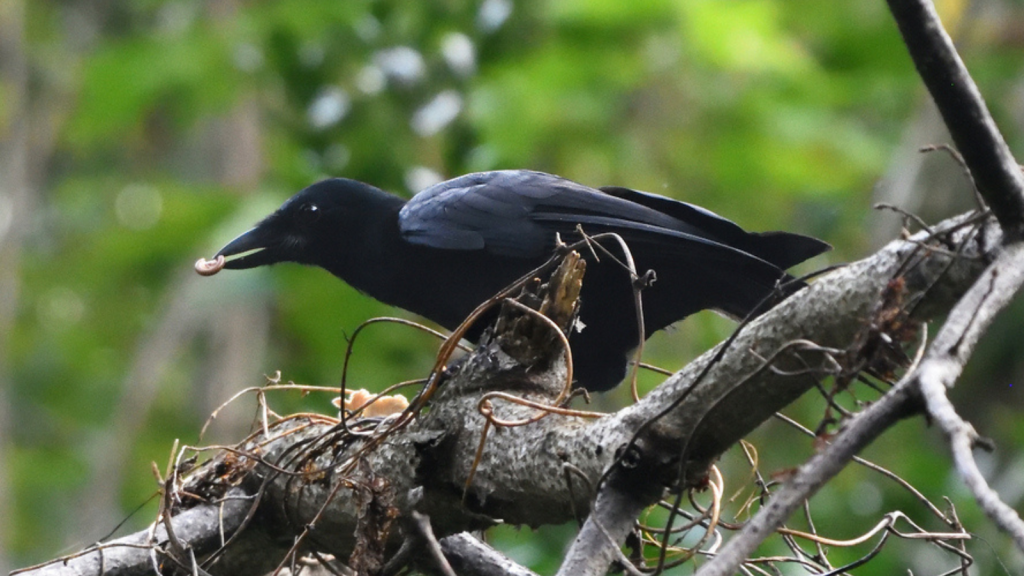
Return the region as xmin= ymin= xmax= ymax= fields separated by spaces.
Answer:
xmin=6 ymin=0 xmax=1022 ymax=574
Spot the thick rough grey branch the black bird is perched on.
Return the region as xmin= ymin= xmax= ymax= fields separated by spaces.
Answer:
xmin=12 ymin=212 xmax=999 ymax=574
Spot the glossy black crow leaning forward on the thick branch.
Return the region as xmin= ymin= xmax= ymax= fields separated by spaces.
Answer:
xmin=203 ymin=170 xmax=829 ymax=390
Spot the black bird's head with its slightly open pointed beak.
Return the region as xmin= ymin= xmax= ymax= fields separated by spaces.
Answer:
xmin=211 ymin=178 xmax=401 ymax=270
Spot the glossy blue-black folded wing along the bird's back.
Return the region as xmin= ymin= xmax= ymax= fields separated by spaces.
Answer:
xmin=399 ymin=170 xmax=827 ymax=269
